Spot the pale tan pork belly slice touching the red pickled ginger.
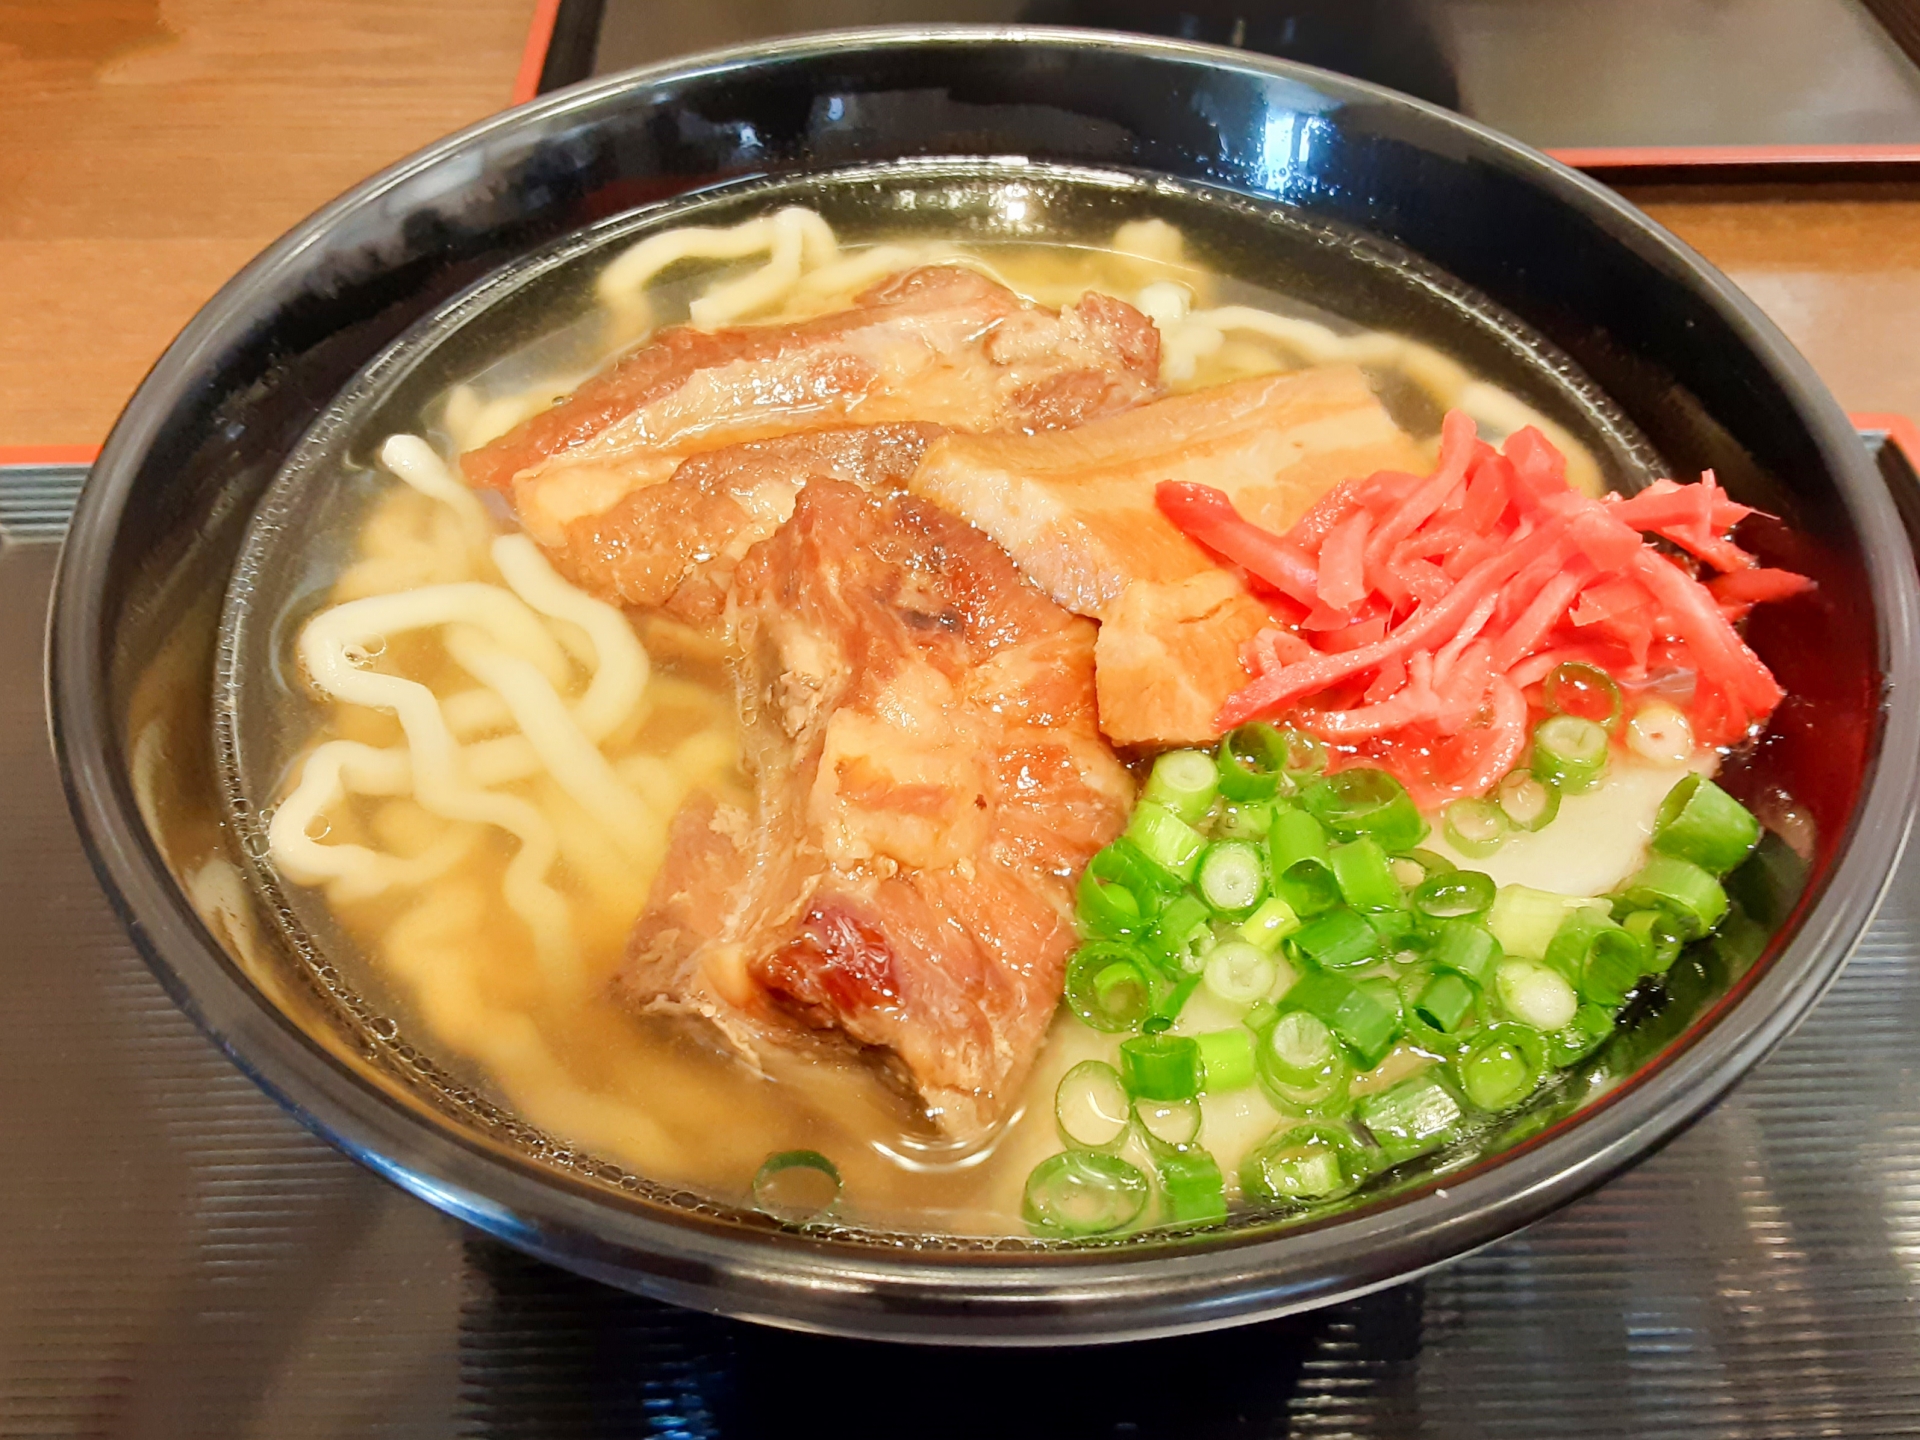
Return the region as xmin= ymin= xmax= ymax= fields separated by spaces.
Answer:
xmin=910 ymin=367 xmax=1427 ymax=745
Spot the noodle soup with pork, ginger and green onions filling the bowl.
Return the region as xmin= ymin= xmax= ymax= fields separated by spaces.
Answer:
xmin=232 ymin=174 xmax=1786 ymax=1238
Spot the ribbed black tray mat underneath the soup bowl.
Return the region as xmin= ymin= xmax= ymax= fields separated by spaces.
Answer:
xmin=15 ymin=443 xmax=1920 ymax=1440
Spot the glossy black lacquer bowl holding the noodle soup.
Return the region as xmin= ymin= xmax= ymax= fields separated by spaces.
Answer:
xmin=50 ymin=31 xmax=1920 ymax=1344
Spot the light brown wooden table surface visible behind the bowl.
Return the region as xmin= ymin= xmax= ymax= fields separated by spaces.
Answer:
xmin=0 ymin=0 xmax=1920 ymax=445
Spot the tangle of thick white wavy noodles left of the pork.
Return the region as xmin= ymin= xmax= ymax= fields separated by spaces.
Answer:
xmin=267 ymin=428 xmax=660 ymax=987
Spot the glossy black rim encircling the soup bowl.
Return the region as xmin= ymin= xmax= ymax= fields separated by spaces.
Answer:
xmin=48 ymin=25 xmax=1920 ymax=1344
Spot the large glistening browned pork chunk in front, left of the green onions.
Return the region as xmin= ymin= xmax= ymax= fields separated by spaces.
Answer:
xmin=622 ymin=480 xmax=1133 ymax=1142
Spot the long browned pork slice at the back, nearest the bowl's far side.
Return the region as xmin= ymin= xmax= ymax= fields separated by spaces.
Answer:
xmin=461 ymin=265 xmax=1160 ymax=553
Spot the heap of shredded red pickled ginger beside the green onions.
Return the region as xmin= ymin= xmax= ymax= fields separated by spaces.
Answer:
xmin=1158 ymin=411 xmax=1812 ymax=808
